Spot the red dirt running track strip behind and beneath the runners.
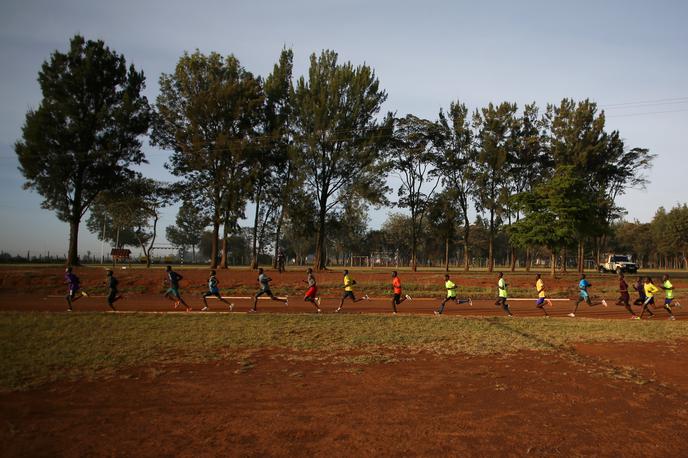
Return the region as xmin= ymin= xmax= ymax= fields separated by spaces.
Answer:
xmin=0 ymin=266 xmax=688 ymax=319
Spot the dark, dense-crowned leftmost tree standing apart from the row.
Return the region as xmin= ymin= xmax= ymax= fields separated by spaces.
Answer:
xmin=14 ymin=35 xmax=150 ymax=264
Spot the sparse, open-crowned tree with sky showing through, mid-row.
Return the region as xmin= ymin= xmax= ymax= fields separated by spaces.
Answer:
xmin=390 ymin=115 xmax=440 ymax=272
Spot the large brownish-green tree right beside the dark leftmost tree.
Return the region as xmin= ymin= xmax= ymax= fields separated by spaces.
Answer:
xmin=152 ymin=51 xmax=264 ymax=268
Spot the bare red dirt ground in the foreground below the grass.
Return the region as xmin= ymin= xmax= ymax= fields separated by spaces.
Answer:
xmin=0 ymin=344 xmax=688 ymax=457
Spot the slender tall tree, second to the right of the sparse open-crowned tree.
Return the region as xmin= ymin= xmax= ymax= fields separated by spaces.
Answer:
xmin=473 ymin=102 xmax=517 ymax=272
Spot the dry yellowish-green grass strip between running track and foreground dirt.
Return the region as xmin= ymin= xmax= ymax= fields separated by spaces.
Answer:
xmin=0 ymin=312 xmax=688 ymax=391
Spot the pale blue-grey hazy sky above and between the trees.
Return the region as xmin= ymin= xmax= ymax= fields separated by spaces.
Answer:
xmin=0 ymin=0 xmax=688 ymax=255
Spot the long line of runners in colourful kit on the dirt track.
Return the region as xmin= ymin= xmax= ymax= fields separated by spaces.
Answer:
xmin=65 ymin=266 xmax=681 ymax=320
